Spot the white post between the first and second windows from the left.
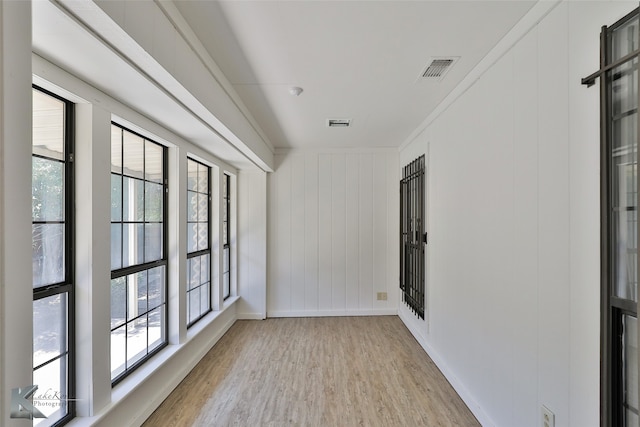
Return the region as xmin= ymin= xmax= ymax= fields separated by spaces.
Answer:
xmin=75 ymin=104 xmax=111 ymax=416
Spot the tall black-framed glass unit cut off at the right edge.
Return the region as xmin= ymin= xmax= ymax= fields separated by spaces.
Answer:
xmin=582 ymin=9 xmax=640 ymax=427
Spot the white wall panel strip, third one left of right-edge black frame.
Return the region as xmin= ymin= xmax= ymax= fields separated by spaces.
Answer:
xmin=508 ymin=28 xmax=539 ymax=426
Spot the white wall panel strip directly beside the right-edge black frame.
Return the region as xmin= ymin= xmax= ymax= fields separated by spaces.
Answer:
xmin=568 ymin=2 xmax=608 ymax=426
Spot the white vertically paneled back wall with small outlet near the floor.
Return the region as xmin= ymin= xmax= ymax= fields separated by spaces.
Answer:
xmin=267 ymin=149 xmax=399 ymax=317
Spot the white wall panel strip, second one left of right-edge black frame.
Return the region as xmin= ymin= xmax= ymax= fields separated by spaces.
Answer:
xmin=538 ymin=3 xmax=568 ymax=425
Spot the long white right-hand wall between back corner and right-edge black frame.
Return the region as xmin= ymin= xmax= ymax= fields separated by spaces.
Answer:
xmin=400 ymin=2 xmax=637 ymax=427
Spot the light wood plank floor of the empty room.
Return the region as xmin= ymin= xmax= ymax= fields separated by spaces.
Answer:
xmin=144 ymin=316 xmax=480 ymax=427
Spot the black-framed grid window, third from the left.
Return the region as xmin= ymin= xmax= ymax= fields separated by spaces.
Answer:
xmin=187 ymin=159 xmax=211 ymax=327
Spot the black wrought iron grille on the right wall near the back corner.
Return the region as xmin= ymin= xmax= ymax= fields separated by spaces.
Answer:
xmin=400 ymin=155 xmax=425 ymax=319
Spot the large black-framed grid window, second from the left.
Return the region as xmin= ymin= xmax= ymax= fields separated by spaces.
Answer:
xmin=111 ymin=123 xmax=168 ymax=385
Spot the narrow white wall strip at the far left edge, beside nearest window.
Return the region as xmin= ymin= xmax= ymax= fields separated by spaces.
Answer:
xmin=0 ymin=2 xmax=33 ymax=427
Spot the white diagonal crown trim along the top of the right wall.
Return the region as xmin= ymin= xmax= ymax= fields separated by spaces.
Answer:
xmin=398 ymin=0 xmax=564 ymax=151
